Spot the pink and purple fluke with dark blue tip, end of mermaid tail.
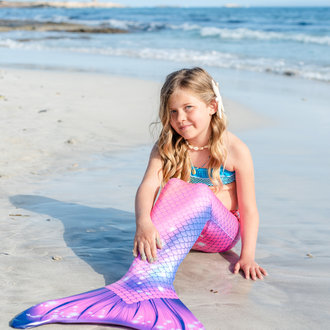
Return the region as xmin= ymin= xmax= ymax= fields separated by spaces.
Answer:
xmin=10 ymin=288 xmax=204 ymax=330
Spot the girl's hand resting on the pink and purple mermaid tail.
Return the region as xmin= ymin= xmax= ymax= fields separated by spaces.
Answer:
xmin=133 ymin=220 xmax=162 ymax=263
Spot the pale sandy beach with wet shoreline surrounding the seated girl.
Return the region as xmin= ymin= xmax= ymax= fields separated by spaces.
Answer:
xmin=0 ymin=4 xmax=330 ymax=330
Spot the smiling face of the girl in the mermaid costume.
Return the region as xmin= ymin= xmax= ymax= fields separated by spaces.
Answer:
xmin=168 ymin=89 xmax=217 ymax=146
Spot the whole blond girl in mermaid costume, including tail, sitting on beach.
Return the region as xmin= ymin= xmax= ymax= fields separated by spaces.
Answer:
xmin=11 ymin=68 xmax=267 ymax=330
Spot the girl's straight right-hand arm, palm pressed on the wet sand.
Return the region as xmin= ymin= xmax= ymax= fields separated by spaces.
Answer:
xmin=232 ymin=138 xmax=267 ymax=280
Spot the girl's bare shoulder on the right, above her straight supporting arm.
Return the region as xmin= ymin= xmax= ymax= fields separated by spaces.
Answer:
xmin=224 ymin=131 xmax=252 ymax=170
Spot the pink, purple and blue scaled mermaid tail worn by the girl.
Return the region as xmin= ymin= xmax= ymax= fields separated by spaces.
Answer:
xmin=11 ymin=179 xmax=240 ymax=330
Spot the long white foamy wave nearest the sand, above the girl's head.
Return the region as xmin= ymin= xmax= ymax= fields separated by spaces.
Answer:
xmin=0 ymin=39 xmax=330 ymax=82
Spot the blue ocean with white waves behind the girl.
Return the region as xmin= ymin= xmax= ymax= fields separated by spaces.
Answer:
xmin=0 ymin=7 xmax=330 ymax=83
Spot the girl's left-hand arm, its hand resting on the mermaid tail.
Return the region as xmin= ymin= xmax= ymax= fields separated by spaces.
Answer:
xmin=133 ymin=145 xmax=162 ymax=262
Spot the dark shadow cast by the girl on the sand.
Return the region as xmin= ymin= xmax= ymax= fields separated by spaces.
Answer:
xmin=10 ymin=195 xmax=135 ymax=284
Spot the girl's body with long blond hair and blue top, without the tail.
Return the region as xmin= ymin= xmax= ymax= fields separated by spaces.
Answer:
xmin=133 ymin=68 xmax=267 ymax=280
